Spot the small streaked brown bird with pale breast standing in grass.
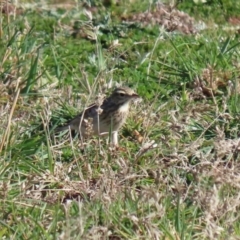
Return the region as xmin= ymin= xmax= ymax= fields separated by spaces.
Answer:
xmin=55 ymin=87 xmax=140 ymax=146
